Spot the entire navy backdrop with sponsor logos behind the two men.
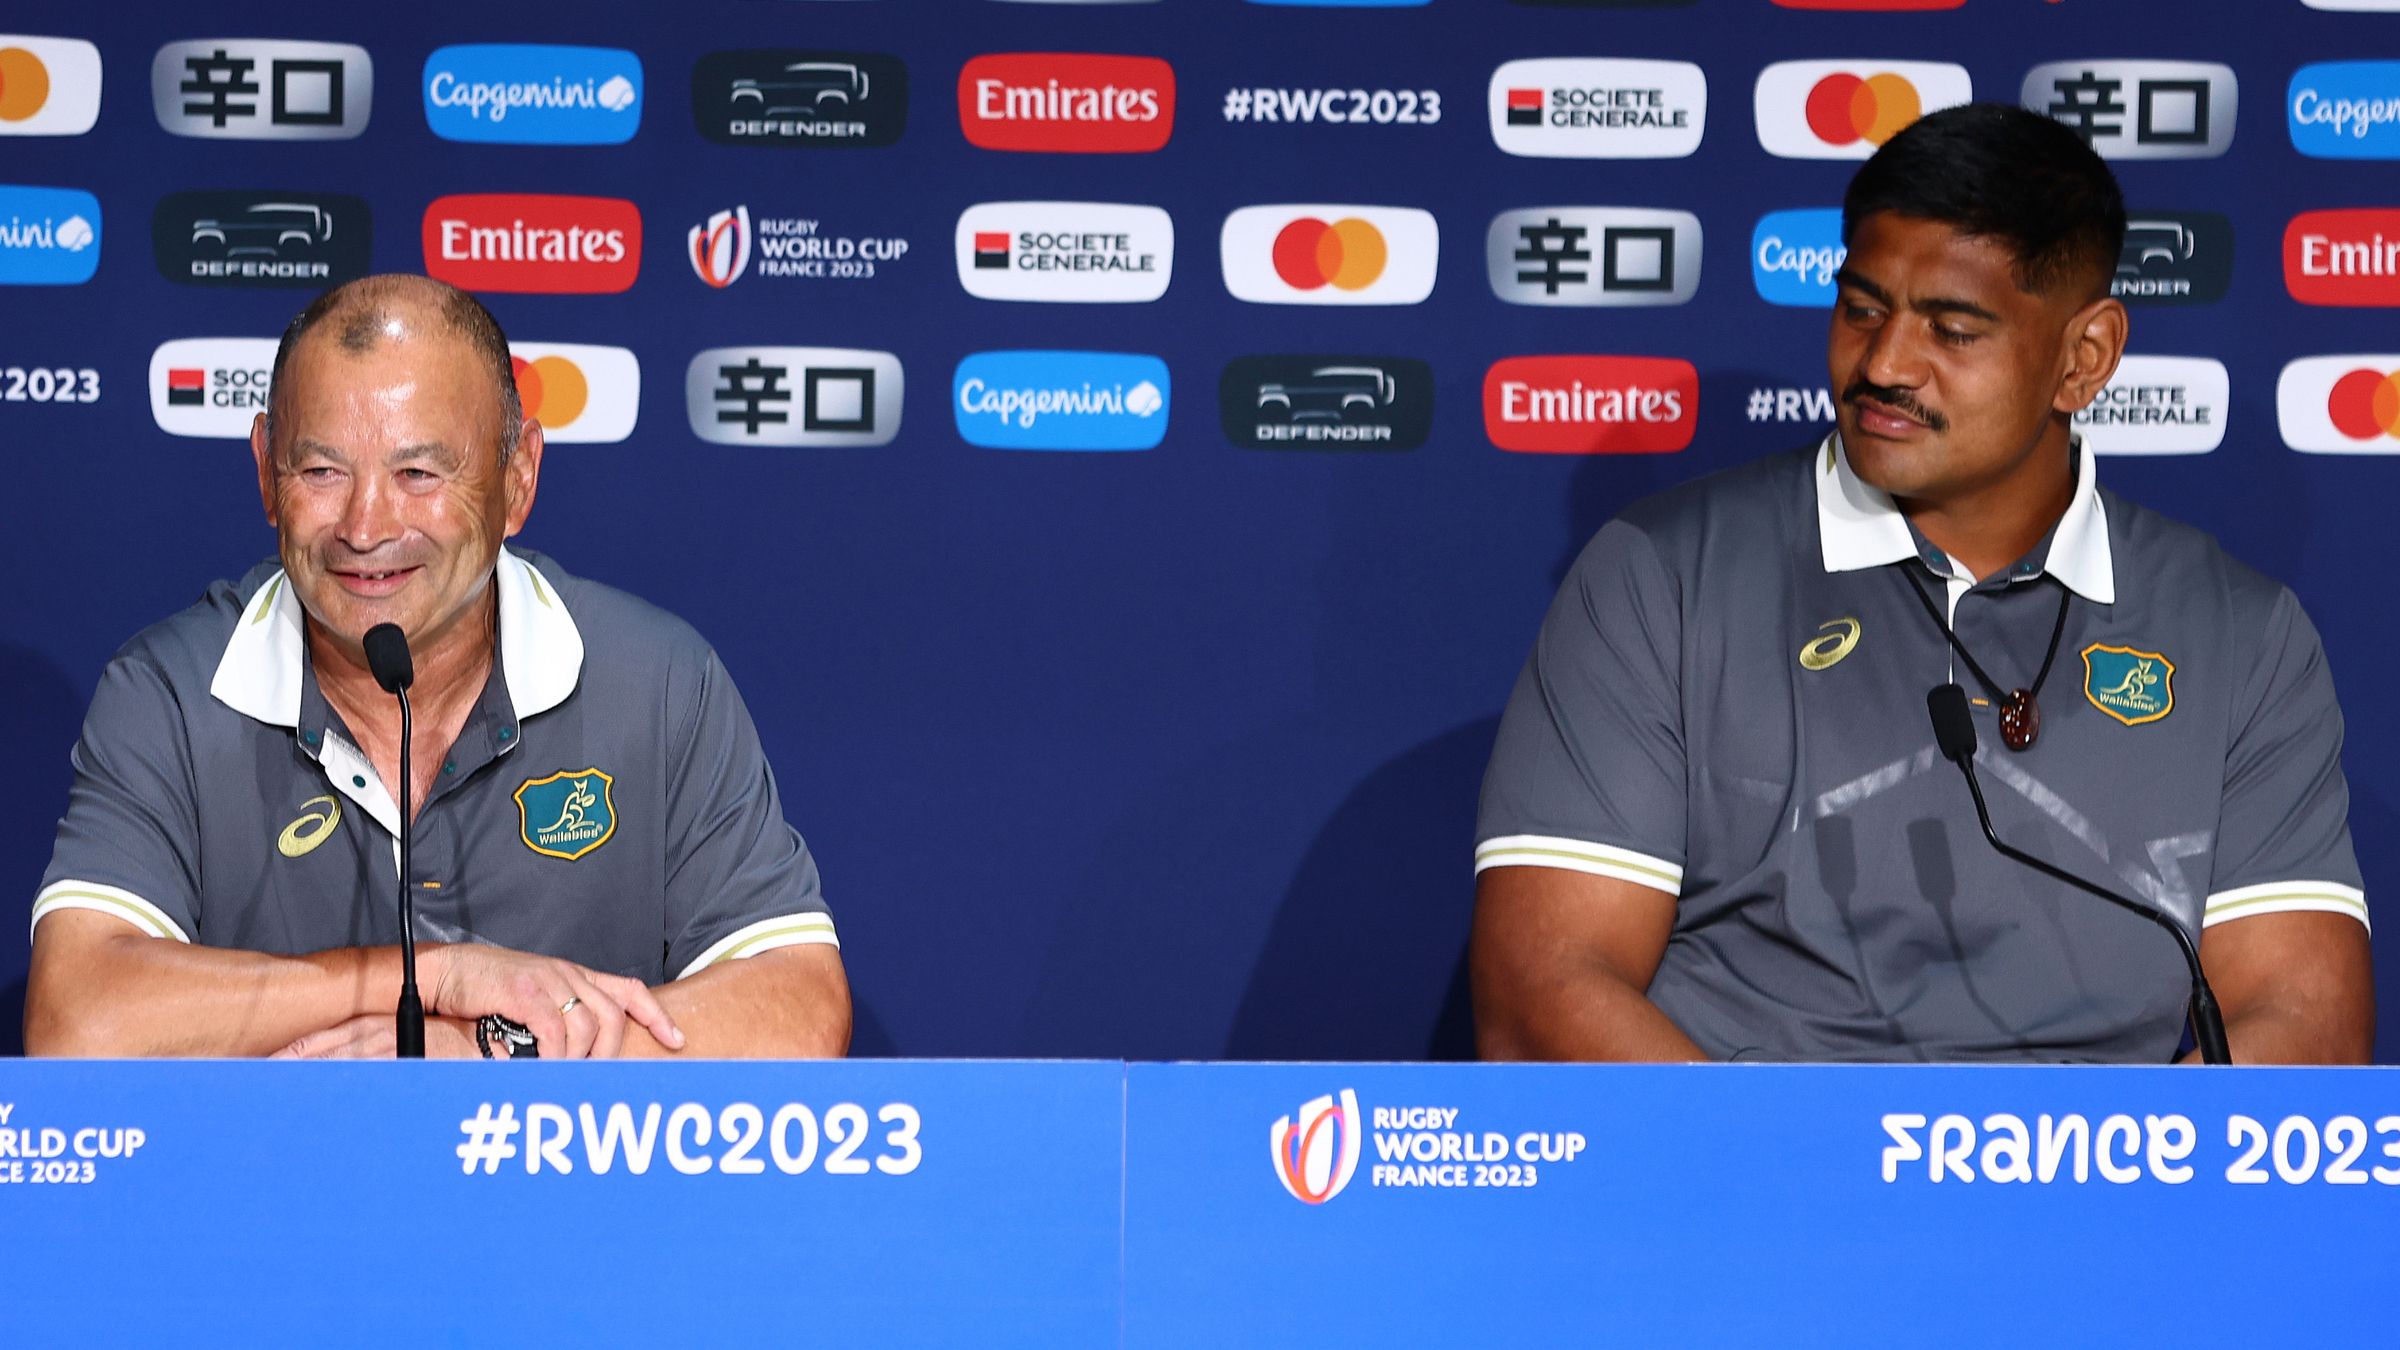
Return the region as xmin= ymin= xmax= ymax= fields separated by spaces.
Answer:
xmin=0 ymin=0 xmax=2400 ymax=1061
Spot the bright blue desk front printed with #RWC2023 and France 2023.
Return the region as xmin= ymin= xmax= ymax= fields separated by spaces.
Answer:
xmin=0 ymin=1062 xmax=2400 ymax=1348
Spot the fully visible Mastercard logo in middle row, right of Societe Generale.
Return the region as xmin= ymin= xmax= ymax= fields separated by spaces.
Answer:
xmin=1217 ymin=204 xmax=1440 ymax=305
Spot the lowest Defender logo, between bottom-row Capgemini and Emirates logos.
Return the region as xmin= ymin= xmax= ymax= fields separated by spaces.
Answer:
xmin=1217 ymin=356 xmax=1433 ymax=449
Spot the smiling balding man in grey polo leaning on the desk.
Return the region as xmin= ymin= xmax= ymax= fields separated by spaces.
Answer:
xmin=24 ymin=276 xmax=850 ymax=1057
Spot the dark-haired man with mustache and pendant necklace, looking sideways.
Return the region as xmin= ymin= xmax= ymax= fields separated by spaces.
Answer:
xmin=1471 ymin=103 xmax=2374 ymax=1064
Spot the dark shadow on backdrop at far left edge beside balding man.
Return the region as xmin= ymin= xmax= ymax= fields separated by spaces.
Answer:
xmin=0 ymin=641 xmax=84 ymax=1055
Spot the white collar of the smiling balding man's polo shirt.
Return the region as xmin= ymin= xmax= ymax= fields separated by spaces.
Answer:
xmin=209 ymin=548 xmax=583 ymax=728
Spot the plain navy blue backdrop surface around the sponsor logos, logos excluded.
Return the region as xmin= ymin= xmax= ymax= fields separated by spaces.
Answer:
xmin=0 ymin=0 xmax=2400 ymax=1059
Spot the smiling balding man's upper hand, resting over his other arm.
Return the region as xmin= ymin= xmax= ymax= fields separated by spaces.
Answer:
xmin=420 ymin=942 xmax=684 ymax=1059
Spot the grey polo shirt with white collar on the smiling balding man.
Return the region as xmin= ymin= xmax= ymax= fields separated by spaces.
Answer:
xmin=34 ymin=550 xmax=835 ymax=985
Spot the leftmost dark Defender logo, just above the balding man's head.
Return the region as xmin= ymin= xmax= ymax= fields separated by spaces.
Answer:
xmin=151 ymin=192 xmax=372 ymax=288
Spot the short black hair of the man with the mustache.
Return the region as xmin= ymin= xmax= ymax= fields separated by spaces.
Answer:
xmin=1841 ymin=103 xmax=2124 ymax=298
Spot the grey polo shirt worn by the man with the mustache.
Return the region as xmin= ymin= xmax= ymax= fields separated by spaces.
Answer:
xmin=1476 ymin=437 xmax=2366 ymax=1062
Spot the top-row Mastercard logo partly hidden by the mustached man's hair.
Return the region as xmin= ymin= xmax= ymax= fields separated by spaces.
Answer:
xmin=1752 ymin=60 xmax=1975 ymax=159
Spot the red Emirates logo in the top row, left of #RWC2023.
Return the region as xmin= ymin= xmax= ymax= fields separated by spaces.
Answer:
xmin=958 ymin=50 xmax=1176 ymax=154
